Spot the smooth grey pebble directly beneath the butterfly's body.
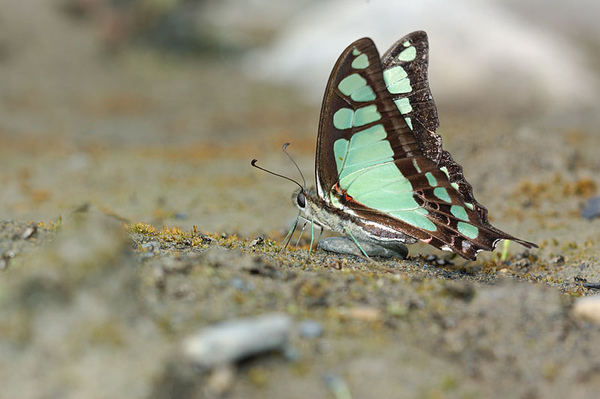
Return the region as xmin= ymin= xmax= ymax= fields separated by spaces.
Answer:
xmin=319 ymin=237 xmax=408 ymax=259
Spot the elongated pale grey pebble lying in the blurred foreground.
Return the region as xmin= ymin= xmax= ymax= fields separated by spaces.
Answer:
xmin=183 ymin=313 xmax=292 ymax=369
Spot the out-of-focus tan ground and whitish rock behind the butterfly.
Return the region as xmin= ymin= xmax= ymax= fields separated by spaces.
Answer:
xmin=0 ymin=0 xmax=600 ymax=238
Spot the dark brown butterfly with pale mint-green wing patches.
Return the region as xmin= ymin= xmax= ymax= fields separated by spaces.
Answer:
xmin=255 ymin=31 xmax=537 ymax=260
